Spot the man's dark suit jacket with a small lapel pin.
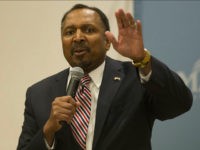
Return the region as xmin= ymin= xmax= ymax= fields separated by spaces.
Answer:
xmin=17 ymin=57 xmax=192 ymax=150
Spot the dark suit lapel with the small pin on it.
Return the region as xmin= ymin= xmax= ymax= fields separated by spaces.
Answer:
xmin=93 ymin=58 xmax=124 ymax=149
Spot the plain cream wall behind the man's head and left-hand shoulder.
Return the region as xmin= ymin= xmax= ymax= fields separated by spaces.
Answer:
xmin=0 ymin=1 xmax=133 ymax=150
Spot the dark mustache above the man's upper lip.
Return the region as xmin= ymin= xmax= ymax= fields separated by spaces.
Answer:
xmin=70 ymin=43 xmax=91 ymax=55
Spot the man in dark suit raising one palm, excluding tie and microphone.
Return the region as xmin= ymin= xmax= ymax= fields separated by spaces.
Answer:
xmin=17 ymin=5 xmax=192 ymax=150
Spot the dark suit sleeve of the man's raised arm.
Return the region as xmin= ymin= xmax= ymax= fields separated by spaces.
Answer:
xmin=145 ymin=57 xmax=192 ymax=120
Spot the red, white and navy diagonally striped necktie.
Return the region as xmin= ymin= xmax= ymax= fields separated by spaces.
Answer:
xmin=71 ymin=75 xmax=91 ymax=150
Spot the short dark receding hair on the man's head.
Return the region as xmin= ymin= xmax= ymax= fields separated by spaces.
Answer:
xmin=61 ymin=4 xmax=110 ymax=31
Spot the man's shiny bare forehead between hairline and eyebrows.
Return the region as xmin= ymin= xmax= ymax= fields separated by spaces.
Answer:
xmin=64 ymin=8 xmax=102 ymax=26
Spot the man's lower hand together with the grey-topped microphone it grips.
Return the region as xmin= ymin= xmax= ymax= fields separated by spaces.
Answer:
xmin=43 ymin=67 xmax=84 ymax=143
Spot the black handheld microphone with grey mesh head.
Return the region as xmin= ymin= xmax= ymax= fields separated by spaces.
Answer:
xmin=59 ymin=67 xmax=84 ymax=126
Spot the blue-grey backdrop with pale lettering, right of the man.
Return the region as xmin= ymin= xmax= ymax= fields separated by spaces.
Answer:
xmin=135 ymin=0 xmax=200 ymax=150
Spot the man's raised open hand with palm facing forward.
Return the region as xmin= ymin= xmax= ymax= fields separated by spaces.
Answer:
xmin=105 ymin=9 xmax=144 ymax=61
